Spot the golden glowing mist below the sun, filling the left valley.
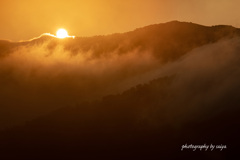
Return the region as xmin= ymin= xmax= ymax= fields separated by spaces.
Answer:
xmin=0 ymin=35 xmax=158 ymax=128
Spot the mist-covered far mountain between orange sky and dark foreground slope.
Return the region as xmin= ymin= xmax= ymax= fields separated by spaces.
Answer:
xmin=0 ymin=21 xmax=239 ymax=128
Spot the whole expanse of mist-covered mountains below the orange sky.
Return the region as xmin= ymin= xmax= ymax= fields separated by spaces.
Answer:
xmin=0 ymin=21 xmax=240 ymax=159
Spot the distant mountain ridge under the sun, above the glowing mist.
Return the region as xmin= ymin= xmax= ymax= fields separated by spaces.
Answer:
xmin=0 ymin=21 xmax=240 ymax=62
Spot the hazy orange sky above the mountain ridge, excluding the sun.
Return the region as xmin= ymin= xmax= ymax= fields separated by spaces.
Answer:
xmin=0 ymin=0 xmax=240 ymax=41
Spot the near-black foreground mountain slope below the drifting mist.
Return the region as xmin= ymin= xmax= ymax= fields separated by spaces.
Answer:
xmin=1 ymin=77 xmax=240 ymax=159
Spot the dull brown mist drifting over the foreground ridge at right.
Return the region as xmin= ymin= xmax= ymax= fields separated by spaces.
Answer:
xmin=149 ymin=37 xmax=240 ymax=126
